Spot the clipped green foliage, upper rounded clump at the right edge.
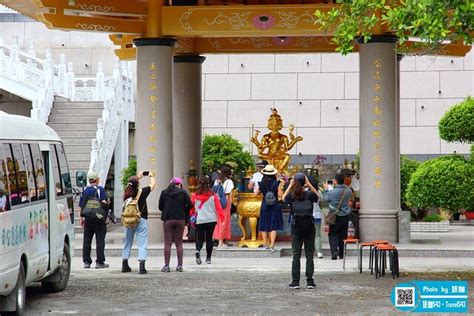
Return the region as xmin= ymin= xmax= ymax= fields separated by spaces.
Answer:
xmin=438 ymin=96 xmax=474 ymax=143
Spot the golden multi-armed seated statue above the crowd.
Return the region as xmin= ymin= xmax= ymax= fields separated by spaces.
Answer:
xmin=250 ymin=108 xmax=303 ymax=173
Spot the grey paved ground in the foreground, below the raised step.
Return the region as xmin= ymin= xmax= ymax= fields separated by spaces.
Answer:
xmin=27 ymin=257 xmax=474 ymax=315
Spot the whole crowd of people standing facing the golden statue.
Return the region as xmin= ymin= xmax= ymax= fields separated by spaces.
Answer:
xmin=79 ymin=161 xmax=352 ymax=289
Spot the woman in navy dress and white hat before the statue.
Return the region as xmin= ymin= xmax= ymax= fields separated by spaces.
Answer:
xmin=255 ymin=165 xmax=283 ymax=251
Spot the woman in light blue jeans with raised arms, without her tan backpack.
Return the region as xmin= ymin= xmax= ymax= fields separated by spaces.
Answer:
xmin=122 ymin=171 xmax=156 ymax=274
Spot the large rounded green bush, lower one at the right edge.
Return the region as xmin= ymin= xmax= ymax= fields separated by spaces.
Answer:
xmin=406 ymin=155 xmax=474 ymax=212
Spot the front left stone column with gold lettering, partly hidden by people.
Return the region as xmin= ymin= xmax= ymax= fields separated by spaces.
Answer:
xmin=134 ymin=38 xmax=176 ymax=244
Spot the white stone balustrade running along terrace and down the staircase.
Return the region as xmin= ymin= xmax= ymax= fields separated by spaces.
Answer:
xmin=0 ymin=36 xmax=135 ymax=186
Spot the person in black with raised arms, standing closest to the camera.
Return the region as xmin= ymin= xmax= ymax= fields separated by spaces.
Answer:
xmin=283 ymin=173 xmax=318 ymax=289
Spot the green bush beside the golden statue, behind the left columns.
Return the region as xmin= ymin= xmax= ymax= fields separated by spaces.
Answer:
xmin=202 ymin=134 xmax=255 ymax=174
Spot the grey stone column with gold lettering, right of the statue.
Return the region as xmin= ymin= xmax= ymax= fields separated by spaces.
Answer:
xmin=359 ymin=36 xmax=400 ymax=242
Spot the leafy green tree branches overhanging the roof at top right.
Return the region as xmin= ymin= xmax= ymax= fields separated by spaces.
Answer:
xmin=315 ymin=0 xmax=474 ymax=55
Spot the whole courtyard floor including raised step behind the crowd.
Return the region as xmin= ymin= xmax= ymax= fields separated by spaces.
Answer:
xmin=20 ymin=225 xmax=474 ymax=315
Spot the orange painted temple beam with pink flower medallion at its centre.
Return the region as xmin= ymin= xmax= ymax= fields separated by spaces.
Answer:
xmin=162 ymin=4 xmax=338 ymax=37
